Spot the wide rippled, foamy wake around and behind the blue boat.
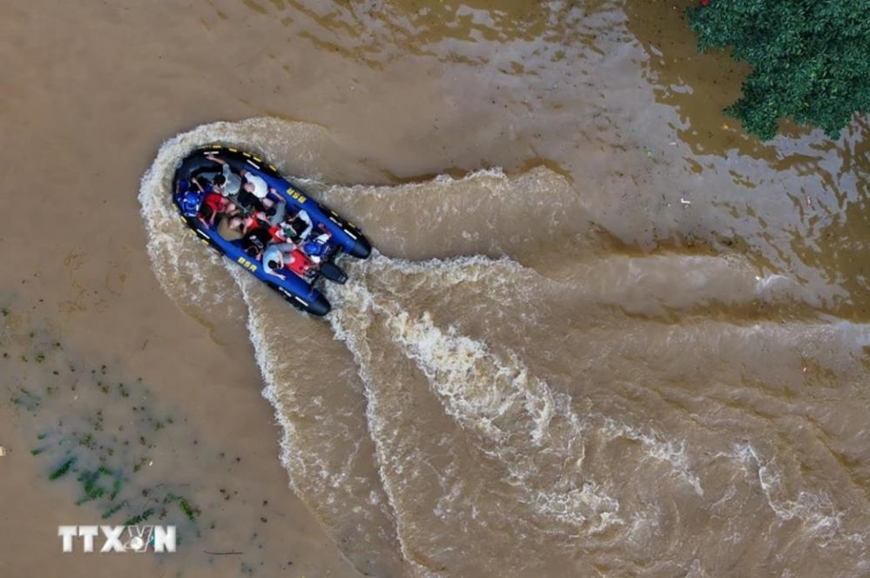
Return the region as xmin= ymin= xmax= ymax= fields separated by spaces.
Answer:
xmin=140 ymin=120 xmax=870 ymax=577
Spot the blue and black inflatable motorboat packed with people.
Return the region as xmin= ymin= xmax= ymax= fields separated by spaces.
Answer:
xmin=172 ymin=145 xmax=371 ymax=316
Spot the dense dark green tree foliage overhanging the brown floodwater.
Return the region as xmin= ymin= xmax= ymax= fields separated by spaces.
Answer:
xmin=688 ymin=0 xmax=870 ymax=140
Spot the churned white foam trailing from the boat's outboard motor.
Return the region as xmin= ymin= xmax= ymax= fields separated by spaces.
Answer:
xmin=330 ymin=254 xmax=728 ymax=544
